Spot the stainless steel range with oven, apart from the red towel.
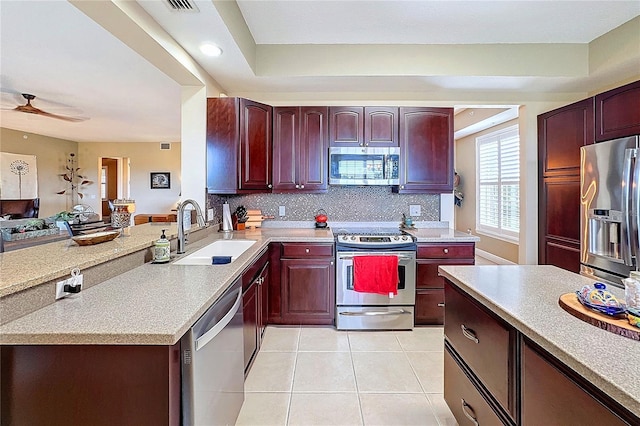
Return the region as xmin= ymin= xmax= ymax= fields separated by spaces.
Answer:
xmin=334 ymin=227 xmax=416 ymax=330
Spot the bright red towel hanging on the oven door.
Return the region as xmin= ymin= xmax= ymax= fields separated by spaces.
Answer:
xmin=353 ymin=256 xmax=398 ymax=295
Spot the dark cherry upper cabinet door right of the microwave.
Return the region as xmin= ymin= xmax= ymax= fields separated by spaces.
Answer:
xmin=398 ymin=107 xmax=453 ymax=193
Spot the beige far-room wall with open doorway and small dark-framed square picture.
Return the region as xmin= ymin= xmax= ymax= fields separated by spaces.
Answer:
xmin=78 ymin=142 xmax=181 ymax=218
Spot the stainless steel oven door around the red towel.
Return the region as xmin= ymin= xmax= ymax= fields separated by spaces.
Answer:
xmin=336 ymin=251 xmax=416 ymax=306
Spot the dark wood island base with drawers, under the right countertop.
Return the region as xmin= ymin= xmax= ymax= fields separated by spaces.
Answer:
xmin=444 ymin=280 xmax=640 ymax=426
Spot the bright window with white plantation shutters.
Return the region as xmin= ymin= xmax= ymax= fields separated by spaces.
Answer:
xmin=476 ymin=126 xmax=520 ymax=242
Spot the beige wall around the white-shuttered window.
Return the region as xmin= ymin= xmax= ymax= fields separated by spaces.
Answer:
xmin=455 ymin=116 xmax=519 ymax=263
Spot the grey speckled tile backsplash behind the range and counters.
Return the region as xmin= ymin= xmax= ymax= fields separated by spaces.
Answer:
xmin=207 ymin=186 xmax=440 ymax=222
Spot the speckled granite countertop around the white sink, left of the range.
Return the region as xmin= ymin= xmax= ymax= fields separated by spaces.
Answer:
xmin=0 ymin=229 xmax=334 ymax=345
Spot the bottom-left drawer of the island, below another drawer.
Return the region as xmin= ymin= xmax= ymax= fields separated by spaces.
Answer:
xmin=444 ymin=350 xmax=503 ymax=425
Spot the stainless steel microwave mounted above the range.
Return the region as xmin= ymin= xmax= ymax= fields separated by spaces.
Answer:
xmin=329 ymin=147 xmax=400 ymax=185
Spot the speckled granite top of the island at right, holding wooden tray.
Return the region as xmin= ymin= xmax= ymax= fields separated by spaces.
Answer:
xmin=439 ymin=265 xmax=640 ymax=416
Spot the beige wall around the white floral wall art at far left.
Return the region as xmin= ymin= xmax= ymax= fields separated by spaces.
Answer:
xmin=0 ymin=128 xmax=78 ymax=218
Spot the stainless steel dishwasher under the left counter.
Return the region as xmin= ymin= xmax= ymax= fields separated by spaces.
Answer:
xmin=180 ymin=279 xmax=244 ymax=426
